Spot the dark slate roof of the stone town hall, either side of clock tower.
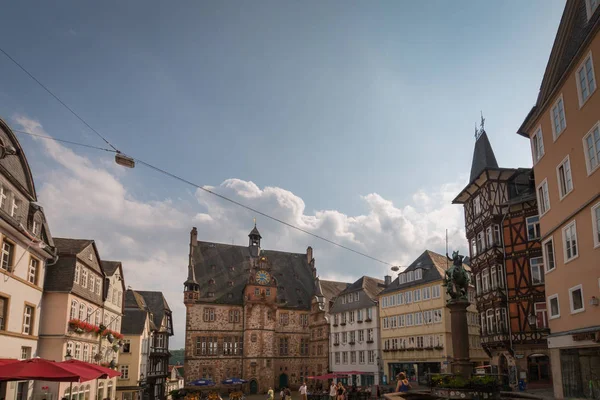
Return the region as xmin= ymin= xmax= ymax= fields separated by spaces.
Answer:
xmin=191 ymin=241 xmax=327 ymax=309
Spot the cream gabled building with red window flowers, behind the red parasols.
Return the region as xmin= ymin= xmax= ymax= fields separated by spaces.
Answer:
xmin=35 ymin=238 xmax=122 ymax=399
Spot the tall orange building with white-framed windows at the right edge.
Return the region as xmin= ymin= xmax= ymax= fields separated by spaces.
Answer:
xmin=518 ymin=0 xmax=600 ymax=398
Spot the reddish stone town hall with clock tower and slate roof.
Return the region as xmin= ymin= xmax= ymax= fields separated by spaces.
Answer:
xmin=184 ymin=226 xmax=345 ymax=393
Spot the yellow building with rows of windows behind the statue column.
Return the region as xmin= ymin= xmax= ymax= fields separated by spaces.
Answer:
xmin=379 ymin=250 xmax=489 ymax=383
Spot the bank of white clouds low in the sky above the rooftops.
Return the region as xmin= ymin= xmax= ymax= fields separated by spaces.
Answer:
xmin=15 ymin=116 xmax=466 ymax=347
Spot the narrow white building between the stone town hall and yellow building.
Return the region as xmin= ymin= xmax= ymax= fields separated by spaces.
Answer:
xmin=329 ymin=276 xmax=385 ymax=386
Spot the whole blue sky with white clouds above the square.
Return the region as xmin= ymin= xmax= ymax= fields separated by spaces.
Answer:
xmin=0 ymin=0 xmax=565 ymax=348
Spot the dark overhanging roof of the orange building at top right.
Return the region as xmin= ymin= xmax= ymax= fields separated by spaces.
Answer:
xmin=517 ymin=0 xmax=600 ymax=137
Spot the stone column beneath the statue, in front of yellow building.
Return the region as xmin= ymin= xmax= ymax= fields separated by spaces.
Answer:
xmin=446 ymin=300 xmax=473 ymax=379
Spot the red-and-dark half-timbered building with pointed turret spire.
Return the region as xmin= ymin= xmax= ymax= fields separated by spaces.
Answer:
xmin=453 ymin=124 xmax=551 ymax=386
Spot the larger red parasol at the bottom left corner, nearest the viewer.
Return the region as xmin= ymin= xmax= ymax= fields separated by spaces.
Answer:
xmin=0 ymin=358 xmax=102 ymax=382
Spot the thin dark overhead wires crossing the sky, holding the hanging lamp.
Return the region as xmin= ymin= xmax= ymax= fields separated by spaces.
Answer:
xmin=0 ymin=47 xmax=394 ymax=267
